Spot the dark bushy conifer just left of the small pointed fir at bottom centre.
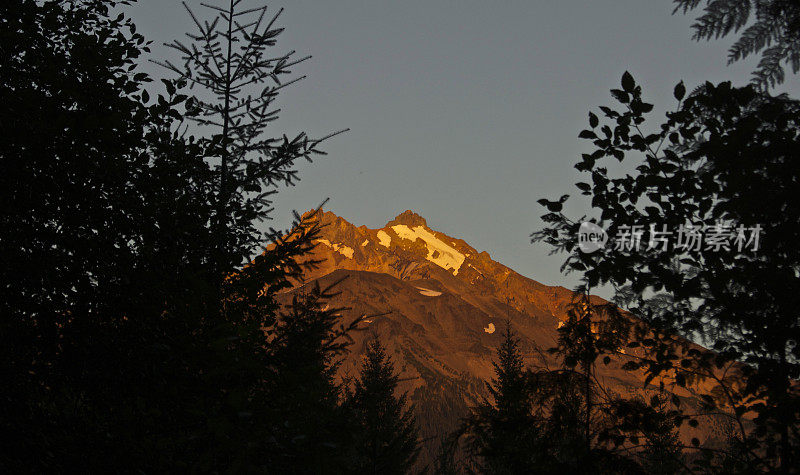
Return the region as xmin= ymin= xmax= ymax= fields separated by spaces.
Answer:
xmin=255 ymin=281 xmax=361 ymax=473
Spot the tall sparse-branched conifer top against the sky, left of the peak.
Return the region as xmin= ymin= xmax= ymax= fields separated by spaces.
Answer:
xmin=155 ymin=0 xmax=343 ymax=286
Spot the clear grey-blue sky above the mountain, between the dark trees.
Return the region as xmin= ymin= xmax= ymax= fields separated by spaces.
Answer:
xmin=128 ymin=0 xmax=800 ymax=286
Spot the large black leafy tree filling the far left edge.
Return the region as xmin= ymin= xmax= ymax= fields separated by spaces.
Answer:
xmin=0 ymin=0 xmax=223 ymax=471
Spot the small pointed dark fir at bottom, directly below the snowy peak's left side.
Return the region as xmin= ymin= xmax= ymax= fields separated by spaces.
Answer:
xmin=347 ymin=337 xmax=420 ymax=475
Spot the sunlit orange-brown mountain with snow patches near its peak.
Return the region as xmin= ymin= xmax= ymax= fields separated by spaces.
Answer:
xmin=280 ymin=211 xmax=724 ymax=466
